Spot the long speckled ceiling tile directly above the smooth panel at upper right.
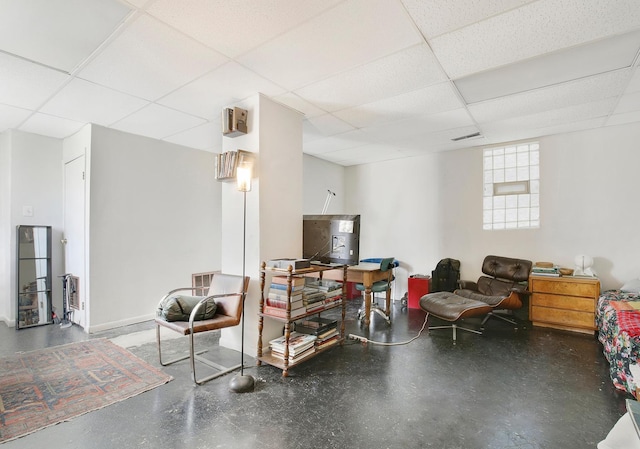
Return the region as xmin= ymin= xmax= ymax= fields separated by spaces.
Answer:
xmin=430 ymin=0 xmax=640 ymax=78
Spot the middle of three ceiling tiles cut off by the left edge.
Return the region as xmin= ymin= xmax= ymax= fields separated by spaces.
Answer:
xmin=0 ymin=51 xmax=71 ymax=109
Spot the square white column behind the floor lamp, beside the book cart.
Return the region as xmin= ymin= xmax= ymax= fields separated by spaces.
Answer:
xmin=220 ymin=94 xmax=303 ymax=356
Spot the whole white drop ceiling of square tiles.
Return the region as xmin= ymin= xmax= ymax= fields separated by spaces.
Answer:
xmin=0 ymin=0 xmax=640 ymax=166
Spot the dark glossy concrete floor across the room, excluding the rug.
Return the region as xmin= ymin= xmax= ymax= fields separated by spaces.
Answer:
xmin=0 ymin=301 xmax=630 ymax=449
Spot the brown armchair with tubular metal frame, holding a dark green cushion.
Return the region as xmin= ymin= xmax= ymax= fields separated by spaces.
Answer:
xmin=155 ymin=273 xmax=249 ymax=385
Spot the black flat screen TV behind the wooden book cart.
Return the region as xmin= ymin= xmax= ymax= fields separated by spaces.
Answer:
xmin=302 ymin=215 xmax=360 ymax=265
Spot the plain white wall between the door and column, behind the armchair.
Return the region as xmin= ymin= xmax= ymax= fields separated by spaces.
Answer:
xmin=89 ymin=125 xmax=221 ymax=332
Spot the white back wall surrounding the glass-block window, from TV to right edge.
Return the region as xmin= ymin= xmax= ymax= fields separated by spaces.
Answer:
xmin=346 ymin=124 xmax=640 ymax=299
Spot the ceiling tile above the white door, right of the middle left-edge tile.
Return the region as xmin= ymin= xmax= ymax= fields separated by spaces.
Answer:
xmin=41 ymin=78 xmax=148 ymax=126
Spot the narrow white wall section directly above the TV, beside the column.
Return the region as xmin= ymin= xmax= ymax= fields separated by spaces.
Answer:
xmin=302 ymin=154 xmax=344 ymax=215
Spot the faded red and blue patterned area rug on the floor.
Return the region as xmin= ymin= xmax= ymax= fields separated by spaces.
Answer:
xmin=0 ymin=339 xmax=172 ymax=443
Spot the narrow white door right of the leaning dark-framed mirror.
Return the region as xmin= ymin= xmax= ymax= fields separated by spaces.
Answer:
xmin=59 ymin=156 xmax=87 ymax=327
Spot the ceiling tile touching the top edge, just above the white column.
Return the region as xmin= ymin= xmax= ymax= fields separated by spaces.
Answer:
xmin=239 ymin=0 xmax=422 ymax=90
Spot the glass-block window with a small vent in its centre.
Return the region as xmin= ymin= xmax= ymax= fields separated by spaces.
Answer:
xmin=482 ymin=142 xmax=540 ymax=230
